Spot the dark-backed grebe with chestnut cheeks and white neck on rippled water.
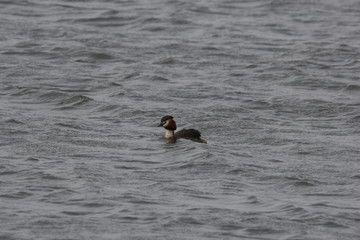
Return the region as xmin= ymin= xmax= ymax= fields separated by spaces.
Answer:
xmin=159 ymin=116 xmax=207 ymax=143
